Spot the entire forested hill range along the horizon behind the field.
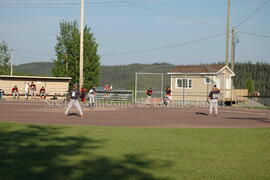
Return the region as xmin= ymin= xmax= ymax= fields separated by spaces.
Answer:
xmin=10 ymin=62 xmax=270 ymax=92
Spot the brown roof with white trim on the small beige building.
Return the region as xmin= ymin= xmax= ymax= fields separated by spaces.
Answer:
xmin=168 ymin=64 xmax=234 ymax=74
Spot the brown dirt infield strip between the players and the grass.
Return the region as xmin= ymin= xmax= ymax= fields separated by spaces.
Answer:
xmin=0 ymin=101 xmax=270 ymax=128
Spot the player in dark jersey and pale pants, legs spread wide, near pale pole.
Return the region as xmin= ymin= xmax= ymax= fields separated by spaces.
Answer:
xmin=65 ymin=84 xmax=83 ymax=117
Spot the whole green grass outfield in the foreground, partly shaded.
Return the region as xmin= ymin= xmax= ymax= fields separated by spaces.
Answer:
xmin=0 ymin=122 xmax=270 ymax=180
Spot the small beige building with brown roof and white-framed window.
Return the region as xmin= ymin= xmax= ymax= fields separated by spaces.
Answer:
xmin=168 ymin=65 xmax=239 ymax=102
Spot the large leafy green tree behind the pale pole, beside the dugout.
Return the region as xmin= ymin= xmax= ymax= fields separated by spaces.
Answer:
xmin=53 ymin=21 xmax=100 ymax=89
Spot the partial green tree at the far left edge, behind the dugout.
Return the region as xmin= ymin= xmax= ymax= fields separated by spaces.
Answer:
xmin=0 ymin=41 xmax=11 ymax=74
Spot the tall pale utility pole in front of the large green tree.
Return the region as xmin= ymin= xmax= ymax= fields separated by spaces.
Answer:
xmin=80 ymin=0 xmax=84 ymax=88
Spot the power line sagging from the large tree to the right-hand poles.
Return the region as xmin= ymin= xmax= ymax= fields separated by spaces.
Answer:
xmin=101 ymin=33 xmax=226 ymax=56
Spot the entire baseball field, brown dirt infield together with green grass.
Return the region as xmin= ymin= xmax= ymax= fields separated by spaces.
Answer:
xmin=0 ymin=101 xmax=270 ymax=180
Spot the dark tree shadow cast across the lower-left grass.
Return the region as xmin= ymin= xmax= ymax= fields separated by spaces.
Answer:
xmin=0 ymin=125 xmax=170 ymax=180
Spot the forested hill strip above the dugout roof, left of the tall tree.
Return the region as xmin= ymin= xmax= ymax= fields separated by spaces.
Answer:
xmin=14 ymin=62 xmax=53 ymax=76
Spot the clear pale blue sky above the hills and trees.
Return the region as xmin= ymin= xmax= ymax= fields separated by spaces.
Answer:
xmin=0 ymin=0 xmax=270 ymax=65
